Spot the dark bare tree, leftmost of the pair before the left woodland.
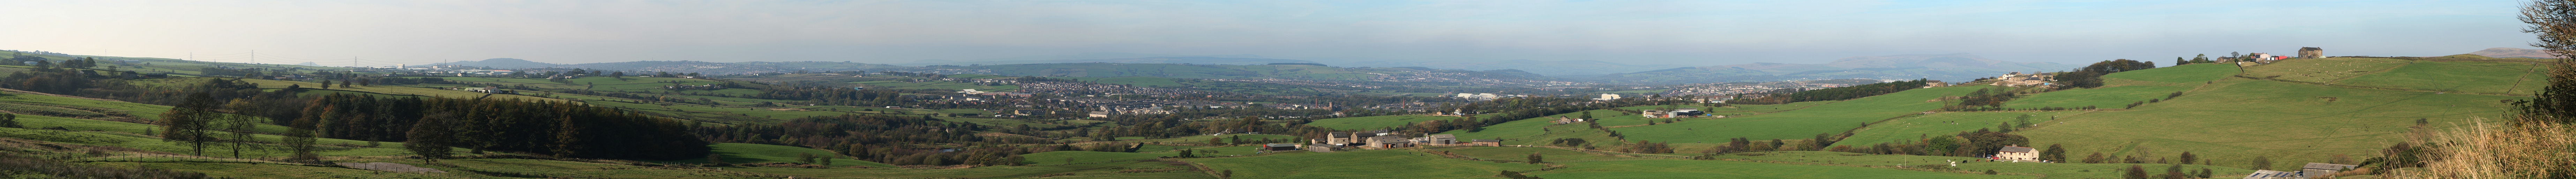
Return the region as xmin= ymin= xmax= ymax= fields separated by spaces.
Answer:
xmin=162 ymin=91 xmax=216 ymax=156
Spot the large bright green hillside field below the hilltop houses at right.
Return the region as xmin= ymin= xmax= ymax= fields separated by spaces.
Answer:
xmin=2020 ymin=80 xmax=2519 ymax=169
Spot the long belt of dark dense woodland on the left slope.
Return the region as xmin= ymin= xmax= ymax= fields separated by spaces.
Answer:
xmin=0 ymin=67 xmax=706 ymax=158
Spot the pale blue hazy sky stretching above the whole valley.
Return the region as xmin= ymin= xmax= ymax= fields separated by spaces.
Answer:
xmin=0 ymin=0 xmax=2532 ymax=65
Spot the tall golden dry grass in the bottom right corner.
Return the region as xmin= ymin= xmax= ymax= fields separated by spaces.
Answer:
xmin=2388 ymin=122 xmax=2576 ymax=179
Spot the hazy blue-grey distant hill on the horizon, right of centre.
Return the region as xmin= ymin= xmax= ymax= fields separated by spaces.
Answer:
xmin=1594 ymin=52 xmax=2081 ymax=83
